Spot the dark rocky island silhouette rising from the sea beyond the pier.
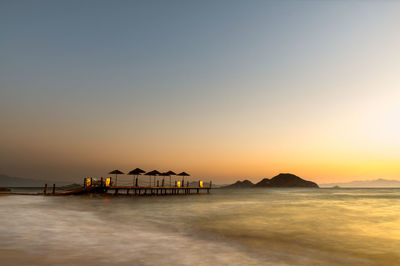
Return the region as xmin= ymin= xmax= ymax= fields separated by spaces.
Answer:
xmin=225 ymin=174 xmax=318 ymax=188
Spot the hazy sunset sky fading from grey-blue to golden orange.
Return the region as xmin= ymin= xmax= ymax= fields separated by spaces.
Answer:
xmin=0 ymin=0 xmax=400 ymax=183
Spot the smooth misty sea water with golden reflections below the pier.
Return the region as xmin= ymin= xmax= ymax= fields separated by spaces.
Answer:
xmin=0 ymin=189 xmax=400 ymax=265
